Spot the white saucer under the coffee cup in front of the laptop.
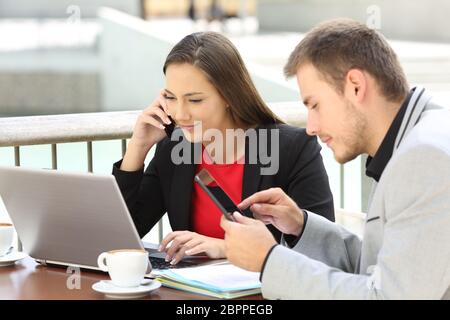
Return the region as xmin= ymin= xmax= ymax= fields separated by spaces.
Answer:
xmin=92 ymin=279 xmax=161 ymax=299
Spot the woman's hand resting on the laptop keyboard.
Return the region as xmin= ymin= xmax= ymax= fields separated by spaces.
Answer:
xmin=159 ymin=231 xmax=225 ymax=265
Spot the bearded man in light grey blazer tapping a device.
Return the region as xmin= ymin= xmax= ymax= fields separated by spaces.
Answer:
xmin=222 ymin=20 xmax=450 ymax=299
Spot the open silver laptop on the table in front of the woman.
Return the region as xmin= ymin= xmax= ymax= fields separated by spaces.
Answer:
xmin=0 ymin=166 xmax=210 ymax=271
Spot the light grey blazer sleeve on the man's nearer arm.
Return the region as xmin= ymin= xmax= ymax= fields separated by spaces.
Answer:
xmin=262 ymin=148 xmax=450 ymax=299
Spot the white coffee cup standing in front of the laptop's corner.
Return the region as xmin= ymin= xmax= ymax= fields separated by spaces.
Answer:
xmin=97 ymin=249 xmax=149 ymax=287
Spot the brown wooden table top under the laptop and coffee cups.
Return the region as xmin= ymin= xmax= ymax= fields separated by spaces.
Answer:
xmin=0 ymin=257 xmax=262 ymax=300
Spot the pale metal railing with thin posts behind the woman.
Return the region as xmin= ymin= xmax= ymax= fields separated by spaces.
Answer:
xmin=0 ymin=102 xmax=320 ymax=241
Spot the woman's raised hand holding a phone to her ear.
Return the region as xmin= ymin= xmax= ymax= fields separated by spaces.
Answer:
xmin=120 ymin=91 xmax=171 ymax=171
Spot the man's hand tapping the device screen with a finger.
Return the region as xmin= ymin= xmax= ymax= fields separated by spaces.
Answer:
xmin=238 ymin=188 xmax=304 ymax=237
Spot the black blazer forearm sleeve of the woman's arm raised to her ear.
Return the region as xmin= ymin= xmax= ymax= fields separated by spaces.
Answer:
xmin=112 ymin=144 xmax=166 ymax=238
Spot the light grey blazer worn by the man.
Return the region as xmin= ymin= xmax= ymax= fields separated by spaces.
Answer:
xmin=262 ymin=88 xmax=450 ymax=299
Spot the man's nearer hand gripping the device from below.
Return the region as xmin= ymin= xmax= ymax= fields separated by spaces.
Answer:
xmin=220 ymin=212 xmax=277 ymax=272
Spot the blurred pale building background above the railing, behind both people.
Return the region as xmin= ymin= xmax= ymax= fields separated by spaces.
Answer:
xmin=0 ymin=0 xmax=450 ymax=116
